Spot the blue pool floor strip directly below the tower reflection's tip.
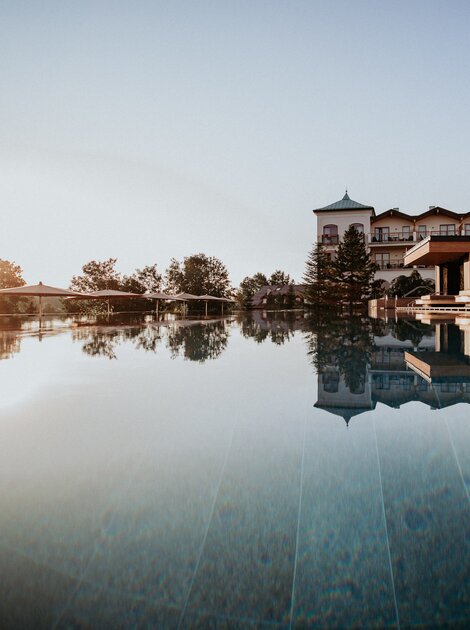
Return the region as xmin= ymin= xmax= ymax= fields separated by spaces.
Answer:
xmin=293 ymin=417 xmax=397 ymax=628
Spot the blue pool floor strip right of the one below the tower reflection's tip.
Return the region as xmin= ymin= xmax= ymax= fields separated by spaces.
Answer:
xmin=376 ymin=411 xmax=470 ymax=626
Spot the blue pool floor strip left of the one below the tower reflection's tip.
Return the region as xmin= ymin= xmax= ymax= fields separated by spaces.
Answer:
xmin=182 ymin=419 xmax=302 ymax=623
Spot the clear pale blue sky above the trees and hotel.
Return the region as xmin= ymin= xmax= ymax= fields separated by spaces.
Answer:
xmin=0 ymin=0 xmax=470 ymax=286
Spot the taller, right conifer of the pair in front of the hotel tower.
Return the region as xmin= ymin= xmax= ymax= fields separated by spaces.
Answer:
xmin=334 ymin=225 xmax=377 ymax=311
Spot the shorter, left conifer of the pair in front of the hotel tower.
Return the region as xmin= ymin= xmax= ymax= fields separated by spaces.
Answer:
xmin=303 ymin=242 xmax=337 ymax=307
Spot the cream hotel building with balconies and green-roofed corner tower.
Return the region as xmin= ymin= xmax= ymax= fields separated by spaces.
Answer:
xmin=313 ymin=191 xmax=470 ymax=283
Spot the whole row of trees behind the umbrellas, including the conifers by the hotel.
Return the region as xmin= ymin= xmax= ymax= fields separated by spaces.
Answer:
xmin=0 ymin=226 xmax=434 ymax=313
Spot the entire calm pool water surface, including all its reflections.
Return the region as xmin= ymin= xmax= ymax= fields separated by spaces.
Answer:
xmin=0 ymin=313 xmax=470 ymax=628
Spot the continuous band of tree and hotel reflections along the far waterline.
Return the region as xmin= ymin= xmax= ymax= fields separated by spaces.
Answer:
xmin=0 ymin=311 xmax=470 ymax=424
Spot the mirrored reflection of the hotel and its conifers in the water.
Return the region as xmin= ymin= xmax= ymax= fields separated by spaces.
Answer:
xmin=307 ymin=319 xmax=470 ymax=425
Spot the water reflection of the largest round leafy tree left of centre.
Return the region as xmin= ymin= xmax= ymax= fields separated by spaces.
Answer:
xmin=167 ymin=321 xmax=229 ymax=363
